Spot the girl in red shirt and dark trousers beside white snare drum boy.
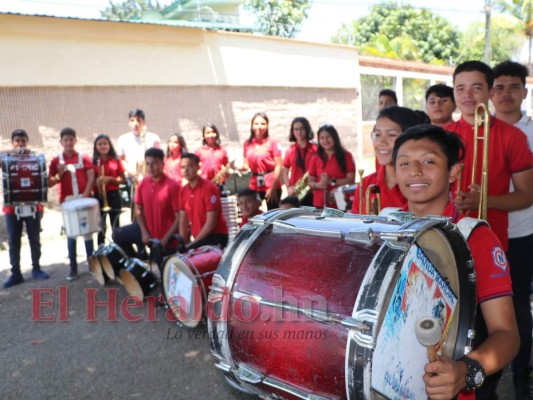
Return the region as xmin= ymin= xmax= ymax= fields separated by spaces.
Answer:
xmin=93 ymin=134 xmax=125 ymax=245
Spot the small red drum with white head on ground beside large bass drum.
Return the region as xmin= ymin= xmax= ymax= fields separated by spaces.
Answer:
xmin=163 ymin=246 xmax=222 ymax=328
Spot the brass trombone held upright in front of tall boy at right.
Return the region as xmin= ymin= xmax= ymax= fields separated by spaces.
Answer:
xmin=472 ymin=103 xmax=490 ymax=220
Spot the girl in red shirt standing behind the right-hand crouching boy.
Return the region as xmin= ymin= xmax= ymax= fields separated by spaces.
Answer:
xmin=195 ymin=123 xmax=228 ymax=187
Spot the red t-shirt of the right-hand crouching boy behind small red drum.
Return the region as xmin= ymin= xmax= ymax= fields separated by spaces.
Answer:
xmin=180 ymin=177 xmax=228 ymax=236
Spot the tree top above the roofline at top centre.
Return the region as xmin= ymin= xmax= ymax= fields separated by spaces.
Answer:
xmin=244 ymin=0 xmax=311 ymax=38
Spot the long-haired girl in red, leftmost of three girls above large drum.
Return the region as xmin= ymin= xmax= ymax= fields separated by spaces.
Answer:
xmin=243 ymin=113 xmax=281 ymax=210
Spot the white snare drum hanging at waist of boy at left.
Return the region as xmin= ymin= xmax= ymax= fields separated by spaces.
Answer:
xmin=61 ymin=197 xmax=100 ymax=238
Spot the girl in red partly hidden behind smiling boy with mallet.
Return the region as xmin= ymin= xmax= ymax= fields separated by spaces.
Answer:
xmin=352 ymin=106 xmax=419 ymax=215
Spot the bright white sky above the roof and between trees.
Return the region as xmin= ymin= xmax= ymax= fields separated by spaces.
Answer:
xmin=0 ymin=0 xmax=485 ymax=42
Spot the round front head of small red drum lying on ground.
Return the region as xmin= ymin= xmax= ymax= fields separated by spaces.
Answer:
xmin=163 ymin=255 xmax=205 ymax=328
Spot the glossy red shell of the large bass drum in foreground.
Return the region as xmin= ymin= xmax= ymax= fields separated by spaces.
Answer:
xmin=208 ymin=211 xmax=475 ymax=399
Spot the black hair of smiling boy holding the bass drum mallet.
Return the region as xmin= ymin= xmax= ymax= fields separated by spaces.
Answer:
xmin=392 ymin=125 xmax=465 ymax=170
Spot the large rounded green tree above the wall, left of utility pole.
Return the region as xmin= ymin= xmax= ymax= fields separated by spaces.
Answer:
xmin=332 ymin=2 xmax=461 ymax=63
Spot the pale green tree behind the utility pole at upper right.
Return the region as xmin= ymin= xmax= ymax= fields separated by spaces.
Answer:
xmin=457 ymin=14 xmax=523 ymax=64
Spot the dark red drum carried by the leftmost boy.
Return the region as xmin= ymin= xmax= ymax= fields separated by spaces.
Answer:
xmin=2 ymin=154 xmax=48 ymax=205
